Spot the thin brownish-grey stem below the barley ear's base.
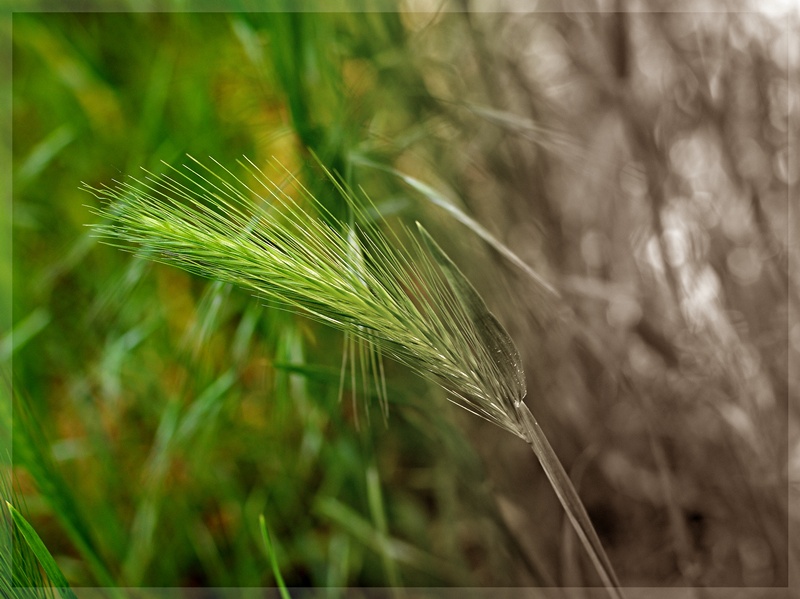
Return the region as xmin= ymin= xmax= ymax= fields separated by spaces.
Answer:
xmin=514 ymin=401 xmax=624 ymax=599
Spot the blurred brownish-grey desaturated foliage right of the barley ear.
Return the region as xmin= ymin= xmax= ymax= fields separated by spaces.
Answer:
xmin=396 ymin=2 xmax=800 ymax=587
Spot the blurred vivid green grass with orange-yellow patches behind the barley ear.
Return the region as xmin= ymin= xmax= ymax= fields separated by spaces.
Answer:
xmin=7 ymin=13 xmax=536 ymax=587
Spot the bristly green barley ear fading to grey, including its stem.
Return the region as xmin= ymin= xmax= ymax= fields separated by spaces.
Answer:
xmin=84 ymin=159 xmax=621 ymax=596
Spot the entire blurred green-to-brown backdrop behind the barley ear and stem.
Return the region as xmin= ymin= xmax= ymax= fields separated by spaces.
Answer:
xmin=0 ymin=0 xmax=800 ymax=587
